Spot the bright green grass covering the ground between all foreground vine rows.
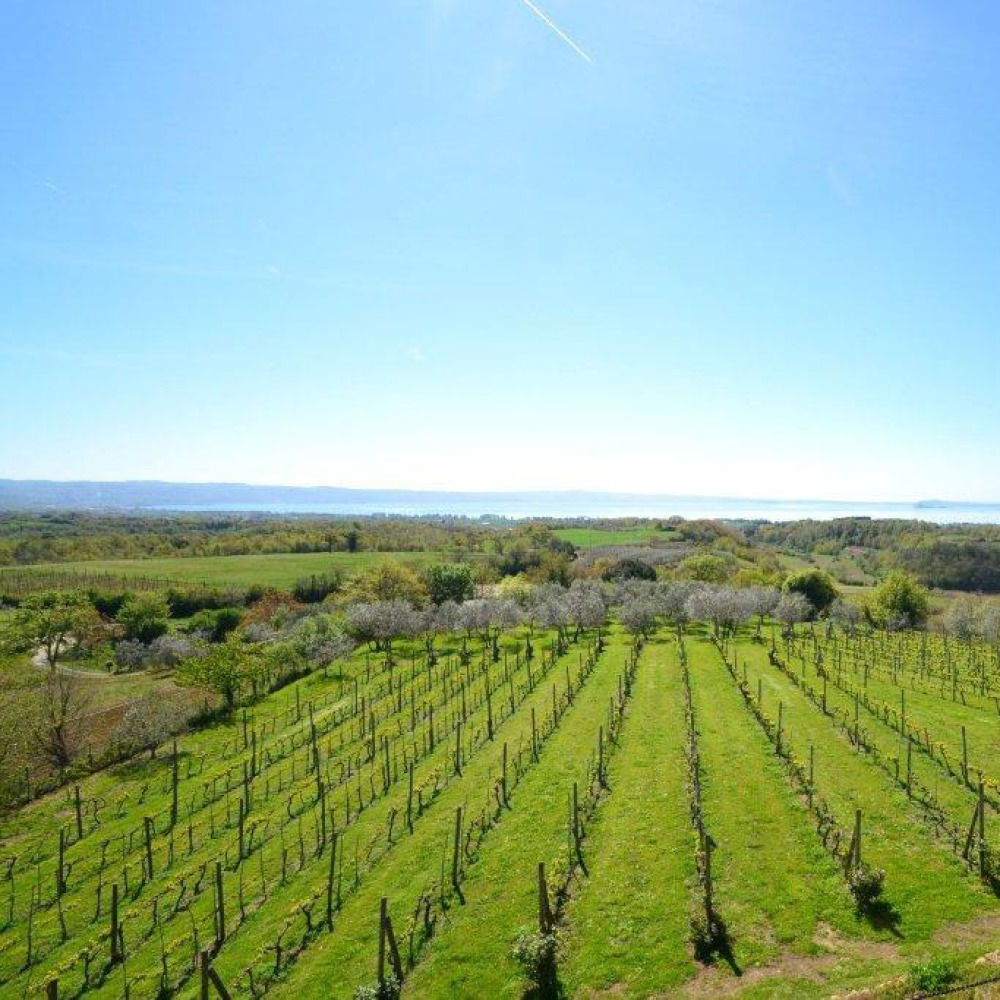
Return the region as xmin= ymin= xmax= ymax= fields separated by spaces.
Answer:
xmin=0 ymin=620 xmax=1000 ymax=1000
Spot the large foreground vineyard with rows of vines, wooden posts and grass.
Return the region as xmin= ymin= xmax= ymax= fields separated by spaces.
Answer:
xmin=0 ymin=621 xmax=1000 ymax=998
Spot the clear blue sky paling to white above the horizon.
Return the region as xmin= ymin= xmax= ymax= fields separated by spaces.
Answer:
xmin=0 ymin=0 xmax=1000 ymax=500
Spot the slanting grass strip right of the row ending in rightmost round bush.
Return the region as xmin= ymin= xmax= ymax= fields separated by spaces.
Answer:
xmin=740 ymin=642 xmax=1000 ymax=941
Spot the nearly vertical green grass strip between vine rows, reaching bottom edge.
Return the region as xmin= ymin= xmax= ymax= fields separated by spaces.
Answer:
xmin=560 ymin=638 xmax=696 ymax=997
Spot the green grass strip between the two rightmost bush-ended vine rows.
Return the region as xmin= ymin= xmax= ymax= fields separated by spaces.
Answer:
xmin=688 ymin=639 xmax=854 ymax=970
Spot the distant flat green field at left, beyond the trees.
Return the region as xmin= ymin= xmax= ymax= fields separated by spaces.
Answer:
xmin=8 ymin=552 xmax=448 ymax=588
